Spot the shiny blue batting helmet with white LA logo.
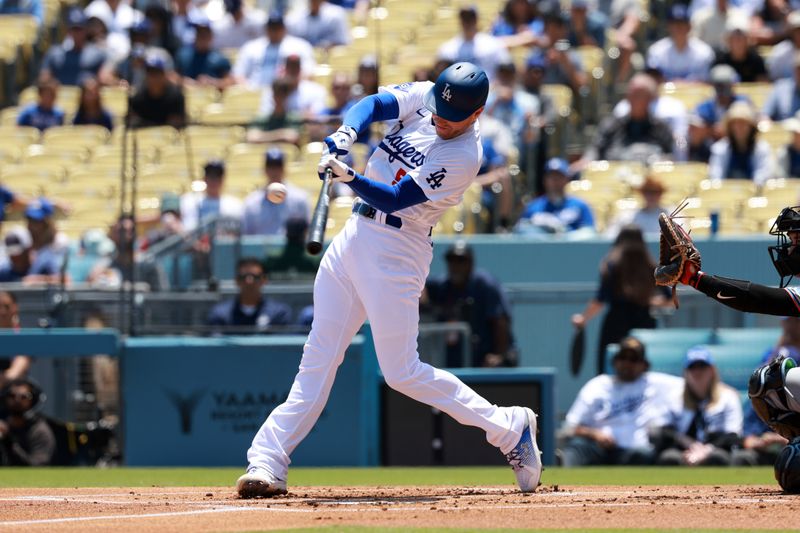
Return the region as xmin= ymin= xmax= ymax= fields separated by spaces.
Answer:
xmin=425 ymin=62 xmax=489 ymax=122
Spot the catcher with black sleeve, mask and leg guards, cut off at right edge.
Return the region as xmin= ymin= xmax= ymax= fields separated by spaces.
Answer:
xmin=655 ymin=204 xmax=800 ymax=493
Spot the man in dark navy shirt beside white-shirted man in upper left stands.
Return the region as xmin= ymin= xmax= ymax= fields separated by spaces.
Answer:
xmin=175 ymin=17 xmax=233 ymax=90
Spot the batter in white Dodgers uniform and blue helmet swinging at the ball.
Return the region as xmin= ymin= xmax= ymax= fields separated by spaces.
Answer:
xmin=236 ymin=63 xmax=542 ymax=498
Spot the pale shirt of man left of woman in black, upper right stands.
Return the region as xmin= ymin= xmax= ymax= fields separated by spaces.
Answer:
xmin=647 ymin=37 xmax=714 ymax=81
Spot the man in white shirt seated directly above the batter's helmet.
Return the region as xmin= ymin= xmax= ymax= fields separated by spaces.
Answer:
xmin=437 ymin=5 xmax=510 ymax=79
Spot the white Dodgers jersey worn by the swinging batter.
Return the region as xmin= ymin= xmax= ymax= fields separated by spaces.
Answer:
xmin=364 ymin=82 xmax=483 ymax=226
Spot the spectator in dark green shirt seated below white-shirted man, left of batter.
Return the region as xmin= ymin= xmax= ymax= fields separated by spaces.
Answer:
xmin=247 ymin=78 xmax=303 ymax=144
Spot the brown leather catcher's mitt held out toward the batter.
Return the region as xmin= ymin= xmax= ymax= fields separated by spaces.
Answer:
xmin=654 ymin=201 xmax=700 ymax=308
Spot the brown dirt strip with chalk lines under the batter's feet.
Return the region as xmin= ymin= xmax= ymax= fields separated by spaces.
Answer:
xmin=0 ymin=486 xmax=800 ymax=533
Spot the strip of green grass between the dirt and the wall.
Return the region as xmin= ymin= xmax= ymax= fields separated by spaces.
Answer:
xmin=0 ymin=467 xmax=775 ymax=487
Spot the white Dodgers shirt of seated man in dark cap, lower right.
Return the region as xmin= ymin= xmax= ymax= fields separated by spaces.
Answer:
xmin=565 ymin=372 xmax=683 ymax=449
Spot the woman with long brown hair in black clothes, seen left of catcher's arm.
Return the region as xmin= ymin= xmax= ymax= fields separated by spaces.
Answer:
xmin=572 ymin=225 xmax=671 ymax=374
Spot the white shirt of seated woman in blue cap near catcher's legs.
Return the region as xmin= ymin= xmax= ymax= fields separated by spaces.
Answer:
xmin=668 ymin=384 xmax=744 ymax=441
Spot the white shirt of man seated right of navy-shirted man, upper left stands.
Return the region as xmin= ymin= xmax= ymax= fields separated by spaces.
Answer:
xmin=232 ymin=35 xmax=317 ymax=88
